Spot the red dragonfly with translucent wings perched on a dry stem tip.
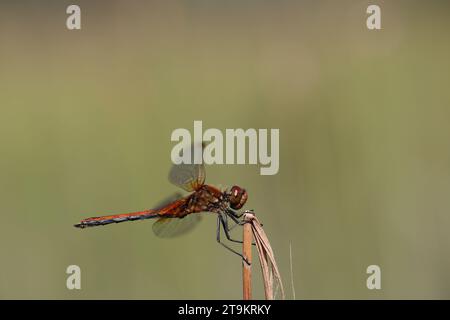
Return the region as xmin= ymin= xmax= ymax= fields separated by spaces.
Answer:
xmin=75 ymin=160 xmax=248 ymax=260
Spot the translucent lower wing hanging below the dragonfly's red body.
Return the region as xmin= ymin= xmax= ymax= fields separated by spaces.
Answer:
xmin=153 ymin=213 xmax=202 ymax=238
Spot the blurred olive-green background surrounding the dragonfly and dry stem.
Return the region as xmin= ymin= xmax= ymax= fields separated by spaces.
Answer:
xmin=0 ymin=0 xmax=450 ymax=299
